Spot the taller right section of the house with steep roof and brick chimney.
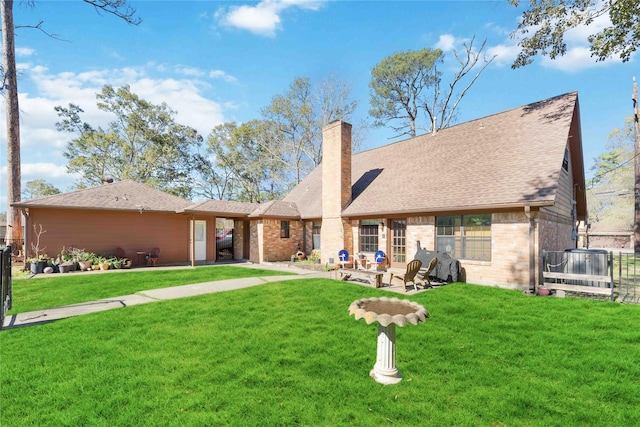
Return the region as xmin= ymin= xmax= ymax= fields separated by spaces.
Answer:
xmin=284 ymin=92 xmax=587 ymax=287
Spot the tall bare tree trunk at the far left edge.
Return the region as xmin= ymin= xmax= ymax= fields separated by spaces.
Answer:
xmin=0 ymin=0 xmax=26 ymax=251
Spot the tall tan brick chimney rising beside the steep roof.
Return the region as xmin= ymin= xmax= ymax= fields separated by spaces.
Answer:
xmin=320 ymin=120 xmax=352 ymax=263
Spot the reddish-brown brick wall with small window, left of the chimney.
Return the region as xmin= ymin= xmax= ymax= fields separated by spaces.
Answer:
xmin=251 ymin=219 xmax=303 ymax=262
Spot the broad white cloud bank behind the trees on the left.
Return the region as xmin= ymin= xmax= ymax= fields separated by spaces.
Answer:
xmin=0 ymin=60 xmax=235 ymax=190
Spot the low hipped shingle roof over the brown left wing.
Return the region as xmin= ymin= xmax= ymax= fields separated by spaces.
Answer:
xmin=12 ymin=180 xmax=192 ymax=212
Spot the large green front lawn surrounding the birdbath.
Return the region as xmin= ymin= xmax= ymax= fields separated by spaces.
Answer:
xmin=0 ymin=279 xmax=640 ymax=426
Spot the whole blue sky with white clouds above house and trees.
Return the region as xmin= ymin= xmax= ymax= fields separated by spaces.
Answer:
xmin=0 ymin=0 xmax=640 ymax=210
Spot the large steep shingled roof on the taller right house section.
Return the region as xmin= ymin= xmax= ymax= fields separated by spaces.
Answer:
xmin=284 ymin=92 xmax=586 ymax=219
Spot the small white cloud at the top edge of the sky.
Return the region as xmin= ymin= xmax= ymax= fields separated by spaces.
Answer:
xmin=215 ymin=0 xmax=324 ymax=37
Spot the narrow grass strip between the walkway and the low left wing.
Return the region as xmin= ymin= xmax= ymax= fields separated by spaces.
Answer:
xmin=9 ymin=266 xmax=289 ymax=314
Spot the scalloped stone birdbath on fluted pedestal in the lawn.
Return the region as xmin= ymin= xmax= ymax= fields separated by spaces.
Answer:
xmin=349 ymin=297 xmax=429 ymax=384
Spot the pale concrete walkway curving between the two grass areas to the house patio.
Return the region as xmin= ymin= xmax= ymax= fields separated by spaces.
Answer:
xmin=3 ymin=263 xmax=420 ymax=329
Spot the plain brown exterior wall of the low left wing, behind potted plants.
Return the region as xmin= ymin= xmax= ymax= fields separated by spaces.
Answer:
xmin=26 ymin=208 xmax=190 ymax=266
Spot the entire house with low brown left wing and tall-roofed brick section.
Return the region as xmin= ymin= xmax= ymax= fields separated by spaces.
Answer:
xmin=16 ymin=92 xmax=587 ymax=286
